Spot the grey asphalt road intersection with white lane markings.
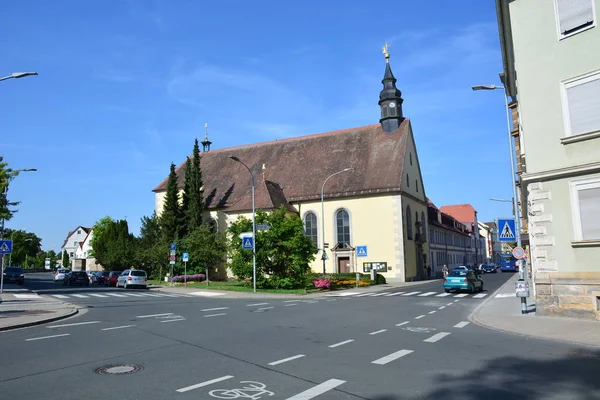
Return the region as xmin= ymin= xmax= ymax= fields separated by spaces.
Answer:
xmin=0 ymin=274 xmax=600 ymax=400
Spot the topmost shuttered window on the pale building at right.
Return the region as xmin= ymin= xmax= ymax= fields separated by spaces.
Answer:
xmin=555 ymin=0 xmax=595 ymax=38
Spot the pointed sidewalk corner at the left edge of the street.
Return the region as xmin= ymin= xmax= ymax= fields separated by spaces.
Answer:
xmin=0 ymin=285 xmax=79 ymax=331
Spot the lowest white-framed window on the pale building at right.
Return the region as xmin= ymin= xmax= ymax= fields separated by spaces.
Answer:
xmin=571 ymin=178 xmax=600 ymax=240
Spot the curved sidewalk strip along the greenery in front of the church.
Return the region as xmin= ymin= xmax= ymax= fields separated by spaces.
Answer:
xmin=150 ymin=279 xmax=441 ymax=299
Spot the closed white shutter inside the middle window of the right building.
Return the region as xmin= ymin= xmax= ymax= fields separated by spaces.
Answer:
xmin=567 ymin=76 xmax=600 ymax=135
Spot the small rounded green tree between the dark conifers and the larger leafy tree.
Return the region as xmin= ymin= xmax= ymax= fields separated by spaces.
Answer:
xmin=180 ymin=225 xmax=227 ymax=274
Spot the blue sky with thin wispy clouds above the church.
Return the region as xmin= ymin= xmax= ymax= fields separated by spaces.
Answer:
xmin=0 ymin=0 xmax=512 ymax=250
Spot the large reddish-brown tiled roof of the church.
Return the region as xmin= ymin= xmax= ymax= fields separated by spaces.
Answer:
xmin=153 ymin=119 xmax=411 ymax=211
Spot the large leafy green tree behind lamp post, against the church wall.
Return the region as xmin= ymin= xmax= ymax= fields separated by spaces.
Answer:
xmin=228 ymin=207 xmax=316 ymax=289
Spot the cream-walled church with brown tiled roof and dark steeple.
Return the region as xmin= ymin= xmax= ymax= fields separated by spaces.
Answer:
xmin=153 ymin=50 xmax=430 ymax=281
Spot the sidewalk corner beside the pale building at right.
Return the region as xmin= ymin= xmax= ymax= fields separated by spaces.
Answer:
xmin=469 ymin=274 xmax=600 ymax=347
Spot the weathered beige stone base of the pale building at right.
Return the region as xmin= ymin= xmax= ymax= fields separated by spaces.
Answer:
xmin=535 ymin=272 xmax=600 ymax=321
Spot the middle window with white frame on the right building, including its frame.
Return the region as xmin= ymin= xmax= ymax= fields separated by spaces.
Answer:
xmin=564 ymin=71 xmax=600 ymax=136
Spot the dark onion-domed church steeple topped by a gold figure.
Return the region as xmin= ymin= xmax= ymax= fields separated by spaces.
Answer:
xmin=379 ymin=43 xmax=404 ymax=133
